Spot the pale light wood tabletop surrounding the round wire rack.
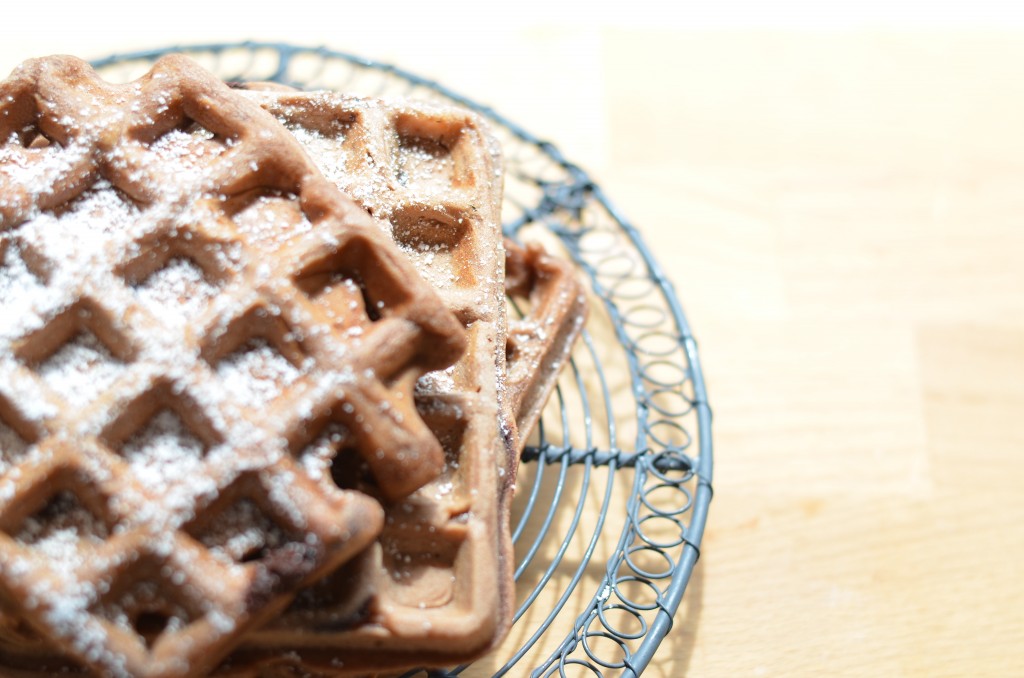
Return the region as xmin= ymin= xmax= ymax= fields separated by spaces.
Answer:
xmin=0 ymin=15 xmax=1024 ymax=676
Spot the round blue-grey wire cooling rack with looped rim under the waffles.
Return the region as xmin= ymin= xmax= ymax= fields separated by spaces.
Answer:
xmin=94 ymin=43 xmax=712 ymax=677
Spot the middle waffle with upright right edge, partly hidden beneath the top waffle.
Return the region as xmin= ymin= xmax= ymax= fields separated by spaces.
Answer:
xmin=217 ymin=91 xmax=515 ymax=675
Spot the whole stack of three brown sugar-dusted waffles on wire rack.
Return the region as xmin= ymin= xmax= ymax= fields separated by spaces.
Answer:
xmin=0 ymin=56 xmax=585 ymax=678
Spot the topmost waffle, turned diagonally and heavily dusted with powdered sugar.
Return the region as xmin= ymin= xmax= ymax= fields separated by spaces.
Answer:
xmin=0 ymin=57 xmax=470 ymax=678
